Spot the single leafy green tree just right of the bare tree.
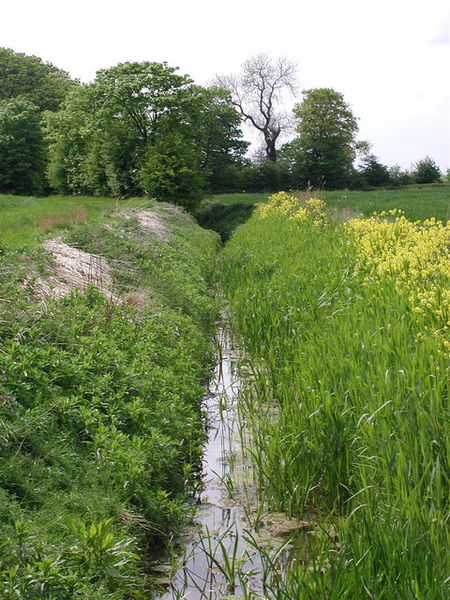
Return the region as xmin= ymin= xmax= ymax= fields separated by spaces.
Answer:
xmin=288 ymin=88 xmax=358 ymax=188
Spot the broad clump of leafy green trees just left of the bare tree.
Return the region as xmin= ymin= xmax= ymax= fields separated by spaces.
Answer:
xmin=46 ymin=62 xmax=247 ymax=208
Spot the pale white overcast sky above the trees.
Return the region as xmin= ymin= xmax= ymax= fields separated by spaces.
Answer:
xmin=0 ymin=0 xmax=450 ymax=170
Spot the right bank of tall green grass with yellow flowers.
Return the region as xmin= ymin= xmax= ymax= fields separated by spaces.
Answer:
xmin=222 ymin=195 xmax=450 ymax=600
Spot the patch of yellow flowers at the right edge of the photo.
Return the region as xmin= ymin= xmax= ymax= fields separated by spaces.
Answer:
xmin=343 ymin=209 xmax=450 ymax=351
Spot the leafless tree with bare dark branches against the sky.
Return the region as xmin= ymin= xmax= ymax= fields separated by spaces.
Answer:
xmin=215 ymin=54 xmax=297 ymax=162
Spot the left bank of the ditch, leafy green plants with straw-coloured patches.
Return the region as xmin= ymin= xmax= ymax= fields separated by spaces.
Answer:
xmin=0 ymin=198 xmax=217 ymax=600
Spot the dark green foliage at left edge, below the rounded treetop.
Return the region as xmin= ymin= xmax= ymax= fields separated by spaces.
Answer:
xmin=0 ymin=99 xmax=46 ymax=195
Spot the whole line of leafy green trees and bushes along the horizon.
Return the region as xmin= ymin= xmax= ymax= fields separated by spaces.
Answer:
xmin=0 ymin=48 xmax=441 ymax=203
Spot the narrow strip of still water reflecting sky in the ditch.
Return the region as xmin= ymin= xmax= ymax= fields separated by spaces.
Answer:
xmin=160 ymin=329 xmax=263 ymax=600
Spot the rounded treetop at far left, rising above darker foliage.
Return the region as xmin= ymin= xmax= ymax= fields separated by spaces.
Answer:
xmin=0 ymin=48 xmax=74 ymax=111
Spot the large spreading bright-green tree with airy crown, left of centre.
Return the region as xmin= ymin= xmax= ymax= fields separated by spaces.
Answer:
xmin=47 ymin=62 xmax=197 ymax=197
